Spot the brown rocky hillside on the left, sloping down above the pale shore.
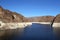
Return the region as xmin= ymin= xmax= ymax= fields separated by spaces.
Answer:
xmin=0 ymin=6 xmax=24 ymax=22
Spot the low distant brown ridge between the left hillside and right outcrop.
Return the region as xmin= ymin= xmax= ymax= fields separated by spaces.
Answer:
xmin=29 ymin=16 xmax=54 ymax=22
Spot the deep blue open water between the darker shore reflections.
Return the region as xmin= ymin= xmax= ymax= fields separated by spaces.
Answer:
xmin=11 ymin=23 xmax=55 ymax=40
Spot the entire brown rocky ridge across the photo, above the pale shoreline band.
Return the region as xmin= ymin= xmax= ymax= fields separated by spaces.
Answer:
xmin=0 ymin=6 xmax=60 ymax=22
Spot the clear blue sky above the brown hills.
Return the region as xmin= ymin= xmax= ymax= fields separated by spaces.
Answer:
xmin=0 ymin=0 xmax=60 ymax=17
